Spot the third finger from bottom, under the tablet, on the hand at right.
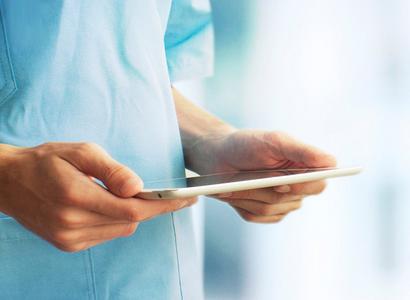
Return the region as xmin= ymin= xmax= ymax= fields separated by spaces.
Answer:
xmin=215 ymin=188 xmax=300 ymax=203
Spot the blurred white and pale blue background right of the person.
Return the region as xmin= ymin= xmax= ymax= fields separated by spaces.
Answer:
xmin=179 ymin=0 xmax=410 ymax=300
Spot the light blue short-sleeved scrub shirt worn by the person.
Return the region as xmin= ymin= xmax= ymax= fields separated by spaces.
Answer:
xmin=0 ymin=0 xmax=212 ymax=299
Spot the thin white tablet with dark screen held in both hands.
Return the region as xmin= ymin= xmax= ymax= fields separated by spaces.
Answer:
xmin=137 ymin=167 xmax=362 ymax=199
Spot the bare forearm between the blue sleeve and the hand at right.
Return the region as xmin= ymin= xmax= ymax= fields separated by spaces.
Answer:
xmin=172 ymin=88 xmax=236 ymax=172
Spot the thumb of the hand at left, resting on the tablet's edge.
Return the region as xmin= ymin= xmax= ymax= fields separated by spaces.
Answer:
xmin=62 ymin=143 xmax=143 ymax=198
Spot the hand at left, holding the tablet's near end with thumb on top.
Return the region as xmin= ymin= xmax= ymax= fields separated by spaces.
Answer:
xmin=0 ymin=143 xmax=196 ymax=252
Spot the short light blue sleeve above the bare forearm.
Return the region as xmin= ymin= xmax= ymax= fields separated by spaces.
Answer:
xmin=165 ymin=0 xmax=214 ymax=82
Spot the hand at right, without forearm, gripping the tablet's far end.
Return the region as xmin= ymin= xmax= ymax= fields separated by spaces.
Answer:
xmin=189 ymin=130 xmax=336 ymax=223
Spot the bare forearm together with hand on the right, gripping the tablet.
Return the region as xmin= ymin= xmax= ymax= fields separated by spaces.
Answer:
xmin=174 ymin=90 xmax=336 ymax=223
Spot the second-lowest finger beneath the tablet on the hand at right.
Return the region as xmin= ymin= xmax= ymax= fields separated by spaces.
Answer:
xmin=230 ymin=200 xmax=302 ymax=216
